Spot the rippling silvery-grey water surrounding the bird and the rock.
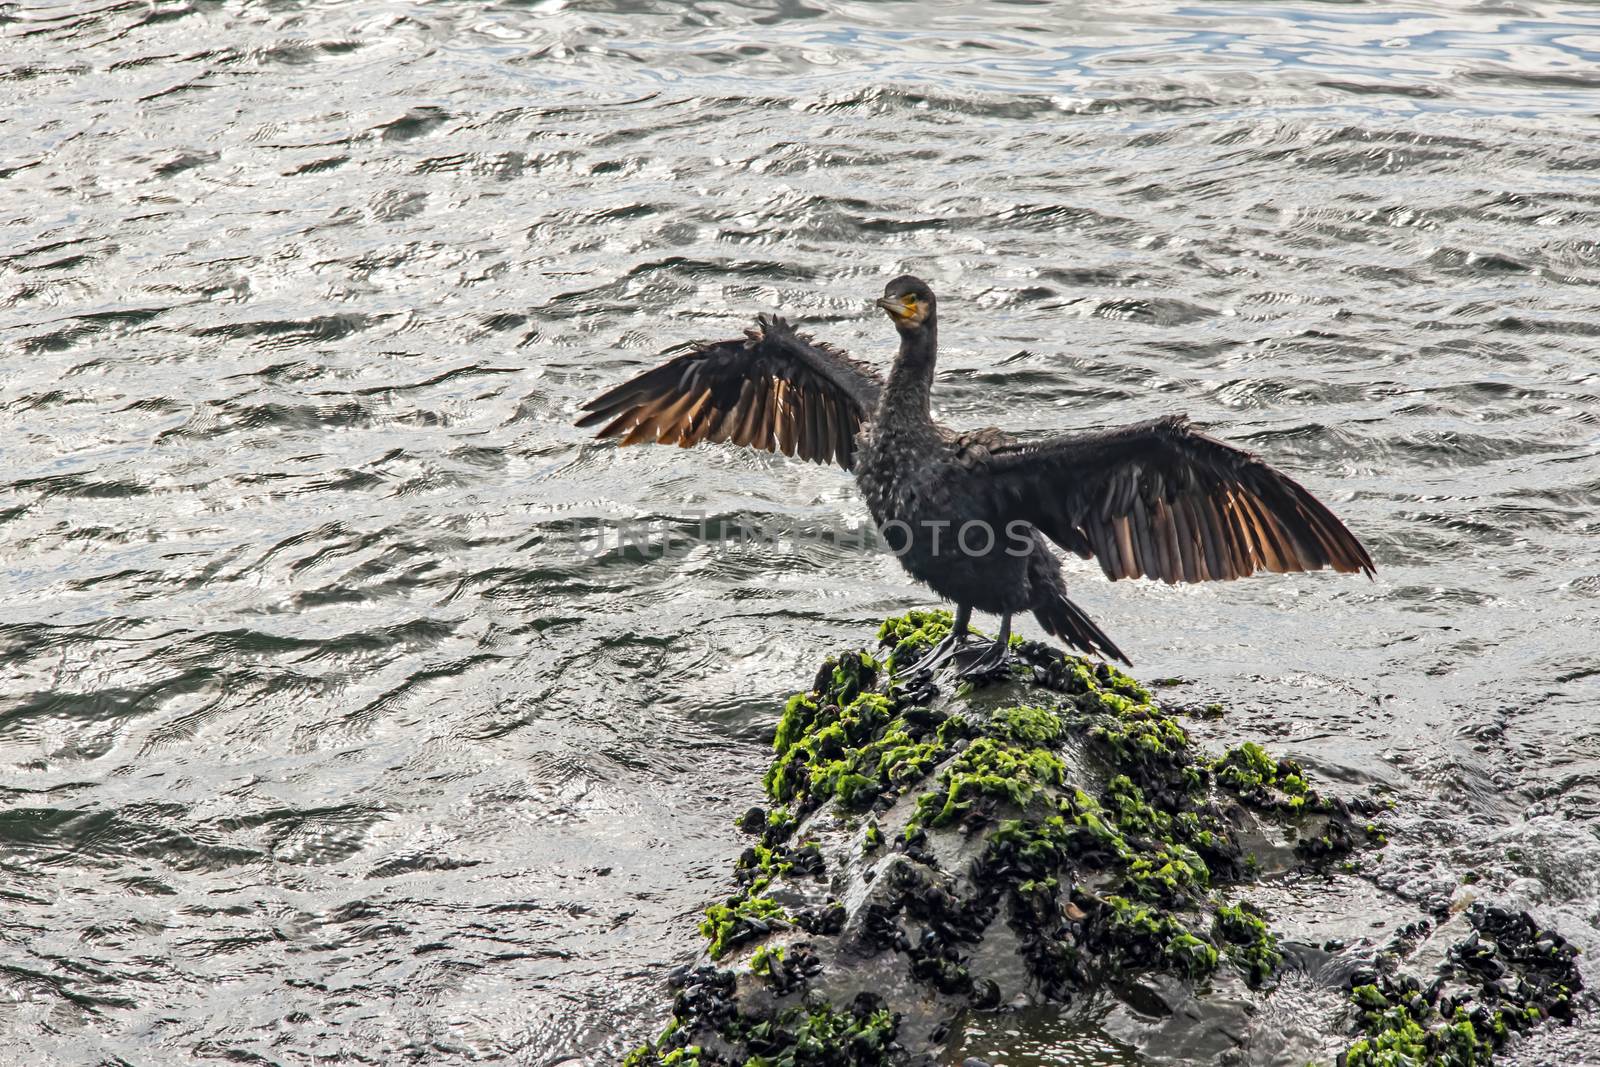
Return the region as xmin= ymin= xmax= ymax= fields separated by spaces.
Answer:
xmin=0 ymin=0 xmax=1600 ymax=1065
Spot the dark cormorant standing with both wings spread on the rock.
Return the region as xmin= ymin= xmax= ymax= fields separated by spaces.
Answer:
xmin=578 ymin=275 xmax=1373 ymax=673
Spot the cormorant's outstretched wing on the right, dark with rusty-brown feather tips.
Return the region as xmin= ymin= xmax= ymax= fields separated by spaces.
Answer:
xmin=984 ymin=416 xmax=1373 ymax=582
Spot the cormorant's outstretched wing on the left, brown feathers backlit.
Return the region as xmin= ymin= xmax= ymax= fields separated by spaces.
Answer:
xmin=578 ymin=315 xmax=883 ymax=470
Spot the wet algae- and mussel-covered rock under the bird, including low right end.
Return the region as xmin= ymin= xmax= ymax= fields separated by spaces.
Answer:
xmin=627 ymin=613 xmax=1582 ymax=1067
